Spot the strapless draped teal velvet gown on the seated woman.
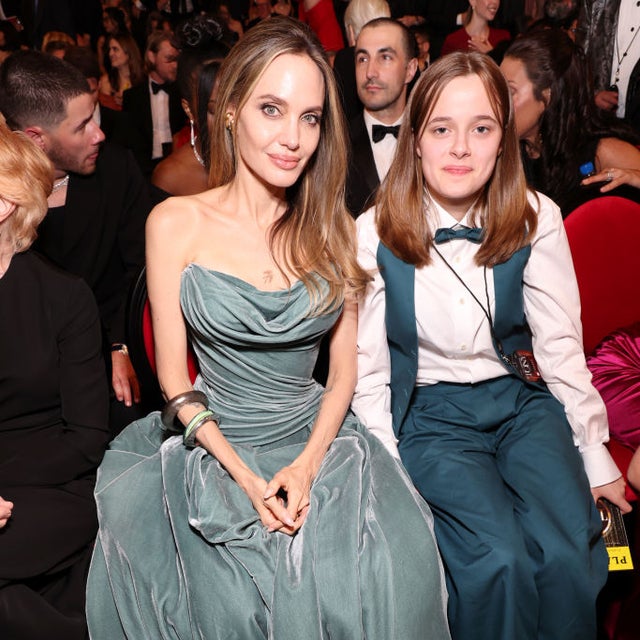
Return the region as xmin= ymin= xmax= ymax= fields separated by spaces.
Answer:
xmin=87 ymin=265 xmax=449 ymax=640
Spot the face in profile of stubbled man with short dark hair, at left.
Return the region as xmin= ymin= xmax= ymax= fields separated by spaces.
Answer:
xmin=44 ymin=93 xmax=104 ymax=175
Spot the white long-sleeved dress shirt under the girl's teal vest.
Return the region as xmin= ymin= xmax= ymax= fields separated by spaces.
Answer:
xmin=351 ymin=193 xmax=620 ymax=487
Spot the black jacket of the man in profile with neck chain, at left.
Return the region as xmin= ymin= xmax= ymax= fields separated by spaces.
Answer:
xmin=34 ymin=143 xmax=151 ymax=343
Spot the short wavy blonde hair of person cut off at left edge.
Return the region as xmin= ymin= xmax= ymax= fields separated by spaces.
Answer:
xmin=0 ymin=122 xmax=53 ymax=253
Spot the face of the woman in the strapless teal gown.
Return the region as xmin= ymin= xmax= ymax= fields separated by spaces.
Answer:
xmin=229 ymin=54 xmax=325 ymax=189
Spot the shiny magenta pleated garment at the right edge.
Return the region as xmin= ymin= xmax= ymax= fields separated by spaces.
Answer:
xmin=587 ymin=322 xmax=640 ymax=449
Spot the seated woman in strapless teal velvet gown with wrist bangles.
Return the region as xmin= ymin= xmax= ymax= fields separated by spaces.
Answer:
xmin=87 ymin=18 xmax=450 ymax=640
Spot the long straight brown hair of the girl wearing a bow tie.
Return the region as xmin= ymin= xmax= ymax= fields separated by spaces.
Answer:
xmin=376 ymin=52 xmax=537 ymax=267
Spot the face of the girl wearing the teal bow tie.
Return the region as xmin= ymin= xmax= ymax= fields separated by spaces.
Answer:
xmin=417 ymin=75 xmax=502 ymax=220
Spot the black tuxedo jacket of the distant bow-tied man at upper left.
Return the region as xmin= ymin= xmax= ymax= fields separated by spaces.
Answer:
xmin=122 ymin=79 xmax=186 ymax=176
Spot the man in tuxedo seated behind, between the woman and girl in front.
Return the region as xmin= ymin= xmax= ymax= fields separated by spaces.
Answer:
xmin=346 ymin=18 xmax=418 ymax=217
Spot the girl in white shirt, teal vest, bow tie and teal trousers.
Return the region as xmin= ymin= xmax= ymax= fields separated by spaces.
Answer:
xmin=352 ymin=53 xmax=630 ymax=640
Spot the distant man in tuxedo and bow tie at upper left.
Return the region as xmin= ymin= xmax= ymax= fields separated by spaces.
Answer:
xmin=122 ymin=32 xmax=185 ymax=176
